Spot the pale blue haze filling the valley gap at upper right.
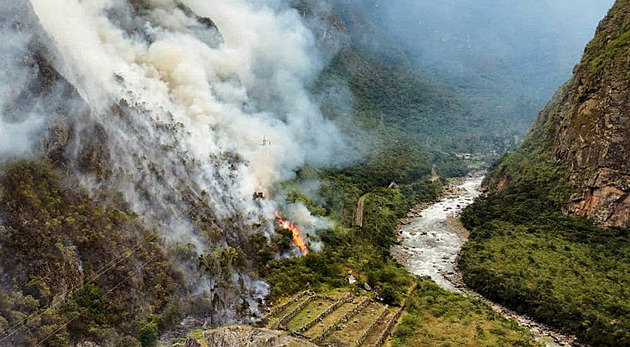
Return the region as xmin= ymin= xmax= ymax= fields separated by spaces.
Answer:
xmin=334 ymin=0 xmax=613 ymax=151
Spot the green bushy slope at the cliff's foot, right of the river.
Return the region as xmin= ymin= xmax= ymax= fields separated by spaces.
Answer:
xmin=459 ymin=151 xmax=630 ymax=345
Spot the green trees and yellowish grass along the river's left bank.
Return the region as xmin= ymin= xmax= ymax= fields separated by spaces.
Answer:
xmin=264 ymin=159 xmax=537 ymax=346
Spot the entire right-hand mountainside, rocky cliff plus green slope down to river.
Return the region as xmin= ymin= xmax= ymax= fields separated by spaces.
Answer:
xmin=460 ymin=1 xmax=630 ymax=346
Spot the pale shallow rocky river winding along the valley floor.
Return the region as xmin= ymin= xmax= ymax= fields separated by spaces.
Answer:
xmin=392 ymin=174 xmax=579 ymax=346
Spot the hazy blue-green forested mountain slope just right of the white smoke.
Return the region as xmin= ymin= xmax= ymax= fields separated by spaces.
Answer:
xmin=315 ymin=4 xmax=513 ymax=176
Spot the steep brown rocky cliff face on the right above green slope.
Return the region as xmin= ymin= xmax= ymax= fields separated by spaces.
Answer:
xmin=493 ymin=0 xmax=630 ymax=227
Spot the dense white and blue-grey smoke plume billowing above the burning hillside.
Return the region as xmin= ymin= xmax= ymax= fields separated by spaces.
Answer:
xmin=23 ymin=0 xmax=345 ymax=235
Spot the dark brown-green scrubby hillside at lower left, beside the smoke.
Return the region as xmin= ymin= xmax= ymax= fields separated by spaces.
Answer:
xmin=0 ymin=161 xmax=187 ymax=346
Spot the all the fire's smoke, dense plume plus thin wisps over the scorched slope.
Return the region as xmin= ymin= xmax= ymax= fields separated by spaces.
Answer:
xmin=8 ymin=0 xmax=348 ymax=324
